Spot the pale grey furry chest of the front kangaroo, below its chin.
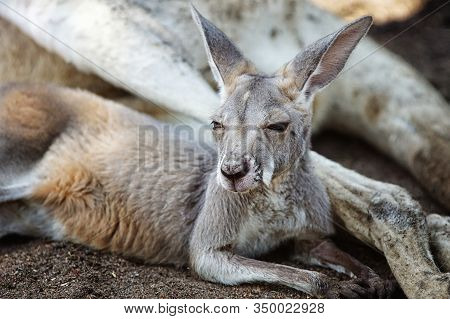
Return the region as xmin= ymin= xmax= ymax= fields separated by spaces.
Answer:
xmin=235 ymin=193 xmax=320 ymax=257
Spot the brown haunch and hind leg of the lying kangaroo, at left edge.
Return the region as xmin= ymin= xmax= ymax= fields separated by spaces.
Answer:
xmin=0 ymin=84 xmax=70 ymax=238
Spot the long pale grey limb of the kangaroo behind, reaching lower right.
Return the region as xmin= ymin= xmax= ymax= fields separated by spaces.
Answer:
xmin=311 ymin=152 xmax=450 ymax=298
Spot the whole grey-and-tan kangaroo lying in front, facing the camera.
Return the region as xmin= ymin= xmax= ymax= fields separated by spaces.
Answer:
xmin=0 ymin=7 xmax=393 ymax=298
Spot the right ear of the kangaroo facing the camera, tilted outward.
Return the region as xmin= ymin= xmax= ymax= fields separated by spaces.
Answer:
xmin=279 ymin=16 xmax=372 ymax=101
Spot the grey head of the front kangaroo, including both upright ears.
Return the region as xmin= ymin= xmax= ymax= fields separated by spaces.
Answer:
xmin=192 ymin=7 xmax=372 ymax=192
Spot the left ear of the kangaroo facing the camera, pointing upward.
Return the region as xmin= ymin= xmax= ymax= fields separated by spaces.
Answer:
xmin=191 ymin=5 xmax=255 ymax=98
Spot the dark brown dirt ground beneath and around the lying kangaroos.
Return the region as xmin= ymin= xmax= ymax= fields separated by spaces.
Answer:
xmin=0 ymin=0 xmax=450 ymax=298
